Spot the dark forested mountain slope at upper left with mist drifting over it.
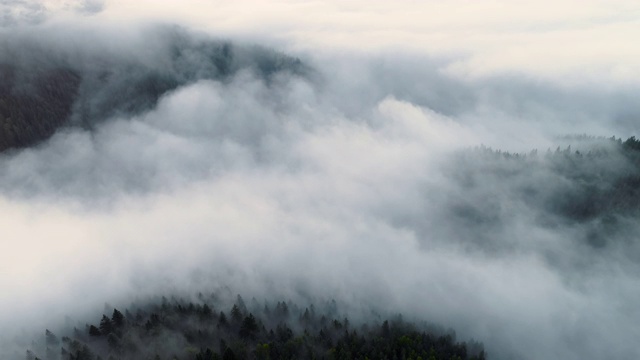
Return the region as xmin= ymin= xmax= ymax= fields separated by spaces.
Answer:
xmin=0 ymin=26 xmax=309 ymax=151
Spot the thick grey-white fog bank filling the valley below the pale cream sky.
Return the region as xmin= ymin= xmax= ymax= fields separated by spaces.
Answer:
xmin=0 ymin=2 xmax=640 ymax=359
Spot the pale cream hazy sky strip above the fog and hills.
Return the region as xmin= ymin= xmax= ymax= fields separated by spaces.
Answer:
xmin=99 ymin=0 xmax=640 ymax=86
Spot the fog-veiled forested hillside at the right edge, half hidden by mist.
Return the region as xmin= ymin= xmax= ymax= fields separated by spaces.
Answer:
xmin=443 ymin=136 xmax=640 ymax=250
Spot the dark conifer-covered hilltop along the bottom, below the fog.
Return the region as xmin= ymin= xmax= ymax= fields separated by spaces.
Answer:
xmin=26 ymin=295 xmax=485 ymax=360
